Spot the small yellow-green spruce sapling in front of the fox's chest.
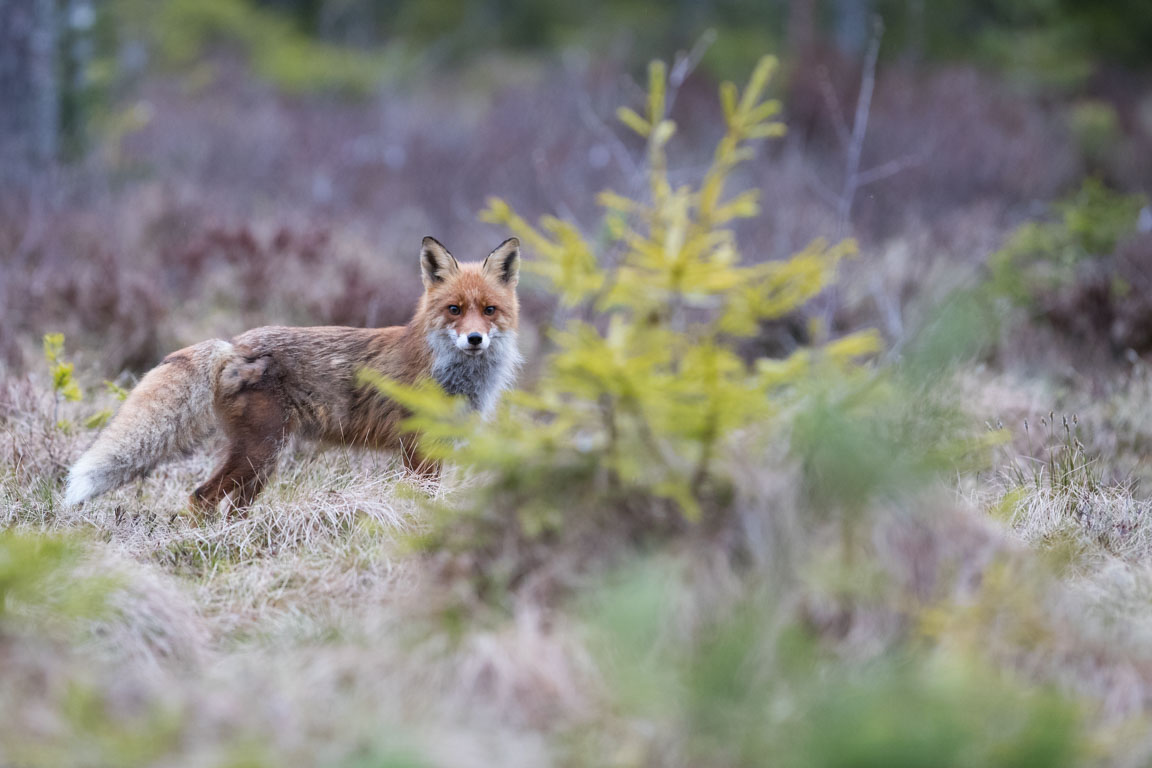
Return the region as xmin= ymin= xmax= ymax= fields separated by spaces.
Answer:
xmin=367 ymin=58 xmax=880 ymax=598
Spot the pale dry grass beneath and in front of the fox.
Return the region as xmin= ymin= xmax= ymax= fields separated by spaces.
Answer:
xmin=0 ymin=363 xmax=608 ymax=766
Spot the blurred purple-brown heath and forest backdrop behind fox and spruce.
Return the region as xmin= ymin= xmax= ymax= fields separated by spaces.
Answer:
xmin=0 ymin=0 xmax=1152 ymax=375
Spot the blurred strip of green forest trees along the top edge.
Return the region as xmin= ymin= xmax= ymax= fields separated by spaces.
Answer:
xmin=94 ymin=0 xmax=1152 ymax=94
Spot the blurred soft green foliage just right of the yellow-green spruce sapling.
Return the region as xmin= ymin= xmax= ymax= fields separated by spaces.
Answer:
xmin=788 ymin=290 xmax=1007 ymax=534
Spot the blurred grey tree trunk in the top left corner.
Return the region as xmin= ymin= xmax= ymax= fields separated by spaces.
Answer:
xmin=0 ymin=0 xmax=59 ymax=169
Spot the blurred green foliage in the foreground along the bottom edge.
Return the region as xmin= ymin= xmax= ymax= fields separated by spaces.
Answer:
xmin=568 ymin=565 xmax=1089 ymax=768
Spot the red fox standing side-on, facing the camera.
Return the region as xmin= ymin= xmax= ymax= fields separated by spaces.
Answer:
xmin=65 ymin=237 xmax=521 ymax=514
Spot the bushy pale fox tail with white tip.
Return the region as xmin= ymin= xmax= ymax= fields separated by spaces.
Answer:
xmin=65 ymin=340 xmax=233 ymax=505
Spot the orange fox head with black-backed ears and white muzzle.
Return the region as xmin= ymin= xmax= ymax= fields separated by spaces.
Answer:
xmin=419 ymin=237 xmax=520 ymax=357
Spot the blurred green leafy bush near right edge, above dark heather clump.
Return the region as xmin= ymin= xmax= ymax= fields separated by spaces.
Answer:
xmin=988 ymin=178 xmax=1146 ymax=307
